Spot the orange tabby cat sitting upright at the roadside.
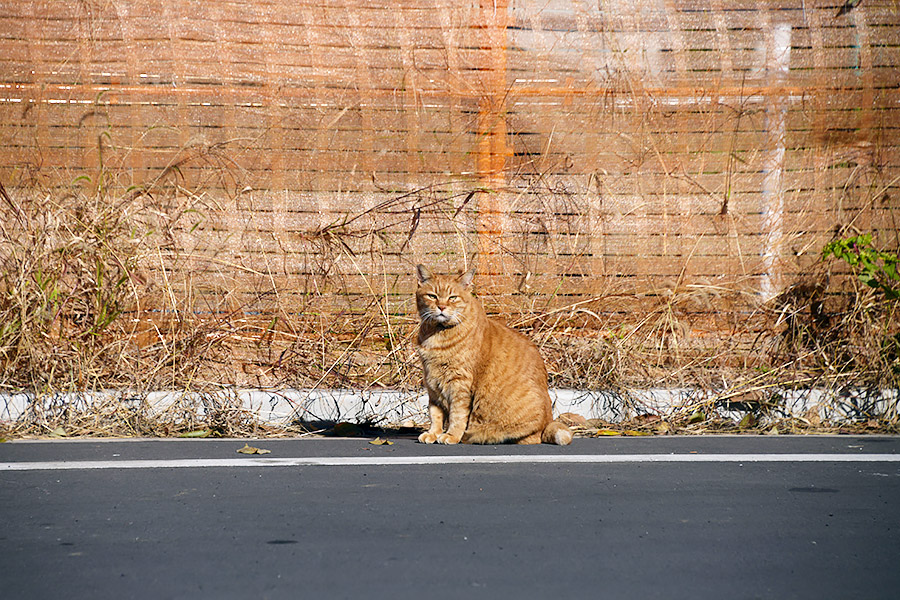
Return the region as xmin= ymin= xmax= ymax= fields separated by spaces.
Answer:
xmin=416 ymin=265 xmax=572 ymax=445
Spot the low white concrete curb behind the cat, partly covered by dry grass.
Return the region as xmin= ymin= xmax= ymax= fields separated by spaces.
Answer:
xmin=0 ymin=388 xmax=900 ymax=425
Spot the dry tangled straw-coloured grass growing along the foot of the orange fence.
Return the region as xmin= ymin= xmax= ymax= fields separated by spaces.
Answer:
xmin=0 ymin=153 xmax=900 ymax=436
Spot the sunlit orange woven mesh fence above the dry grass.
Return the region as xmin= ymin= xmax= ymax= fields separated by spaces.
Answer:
xmin=0 ymin=0 xmax=900 ymax=328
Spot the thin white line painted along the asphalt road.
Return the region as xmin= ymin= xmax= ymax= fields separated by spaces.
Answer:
xmin=0 ymin=454 xmax=900 ymax=471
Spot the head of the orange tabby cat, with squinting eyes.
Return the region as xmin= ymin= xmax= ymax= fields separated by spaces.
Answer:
xmin=416 ymin=265 xmax=475 ymax=328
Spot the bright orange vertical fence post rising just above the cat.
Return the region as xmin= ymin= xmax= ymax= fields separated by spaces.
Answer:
xmin=475 ymin=0 xmax=508 ymax=288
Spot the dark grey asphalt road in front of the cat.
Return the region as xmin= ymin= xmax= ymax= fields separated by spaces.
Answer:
xmin=0 ymin=436 xmax=900 ymax=600
